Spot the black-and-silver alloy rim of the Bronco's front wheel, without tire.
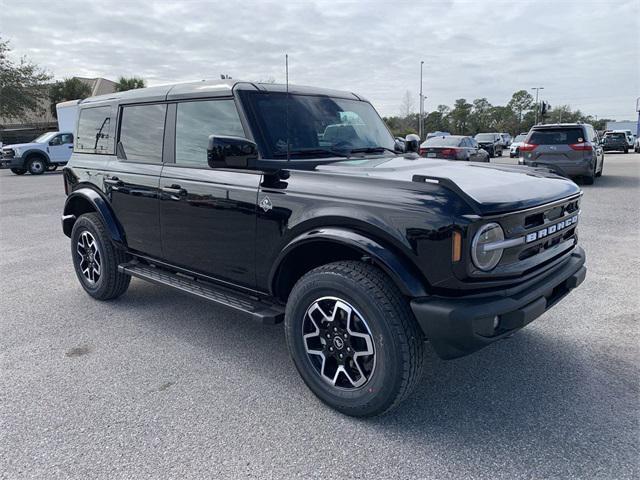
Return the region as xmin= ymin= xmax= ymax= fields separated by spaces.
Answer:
xmin=302 ymin=297 xmax=376 ymax=390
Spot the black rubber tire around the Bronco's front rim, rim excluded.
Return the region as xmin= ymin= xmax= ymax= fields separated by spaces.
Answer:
xmin=285 ymin=261 xmax=425 ymax=417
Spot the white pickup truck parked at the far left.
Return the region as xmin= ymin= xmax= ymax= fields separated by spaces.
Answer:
xmin=0 ymin=132 xmax=73 ymax=175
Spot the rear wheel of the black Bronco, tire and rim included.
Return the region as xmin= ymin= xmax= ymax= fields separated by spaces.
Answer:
xmin=71 ymin=213 xmax=131 ymax=300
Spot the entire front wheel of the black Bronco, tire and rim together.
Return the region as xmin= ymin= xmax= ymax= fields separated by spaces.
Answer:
xmin=285 ymin=261 xmax=424 ymax=417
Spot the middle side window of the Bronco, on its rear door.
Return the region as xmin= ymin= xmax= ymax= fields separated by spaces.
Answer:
xmin=119 ymin=104 xmax=167 ymax=163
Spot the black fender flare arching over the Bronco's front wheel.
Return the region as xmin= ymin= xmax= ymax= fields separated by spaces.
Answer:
xmin=269 ymin=227 xmax=428 ymax=297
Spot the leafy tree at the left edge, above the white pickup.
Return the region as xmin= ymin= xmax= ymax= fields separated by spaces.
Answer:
xmin=0 ymin=37 xmax=51 ymax=119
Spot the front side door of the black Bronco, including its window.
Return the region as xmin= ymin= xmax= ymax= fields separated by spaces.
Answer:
xmin=160 ymin=95 xmax=262 ymax=288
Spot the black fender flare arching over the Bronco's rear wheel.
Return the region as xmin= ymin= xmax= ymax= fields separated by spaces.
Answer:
xmin=62 ymin=187 xmax=126 ymax=245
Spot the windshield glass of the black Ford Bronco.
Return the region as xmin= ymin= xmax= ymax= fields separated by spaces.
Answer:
xmin=240 ymin=91 xmax=395 ymax=158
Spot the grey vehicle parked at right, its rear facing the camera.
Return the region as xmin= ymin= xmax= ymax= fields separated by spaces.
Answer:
xmin=519 ymin=123 xmax=606 ymax=185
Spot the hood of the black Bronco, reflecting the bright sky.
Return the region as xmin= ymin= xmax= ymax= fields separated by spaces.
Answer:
xmin=316 ymin=156 xmax=580 ymax=215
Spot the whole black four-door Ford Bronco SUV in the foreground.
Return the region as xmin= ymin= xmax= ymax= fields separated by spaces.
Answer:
xmin=62 ymin=80 xmax=586 ymax=416
